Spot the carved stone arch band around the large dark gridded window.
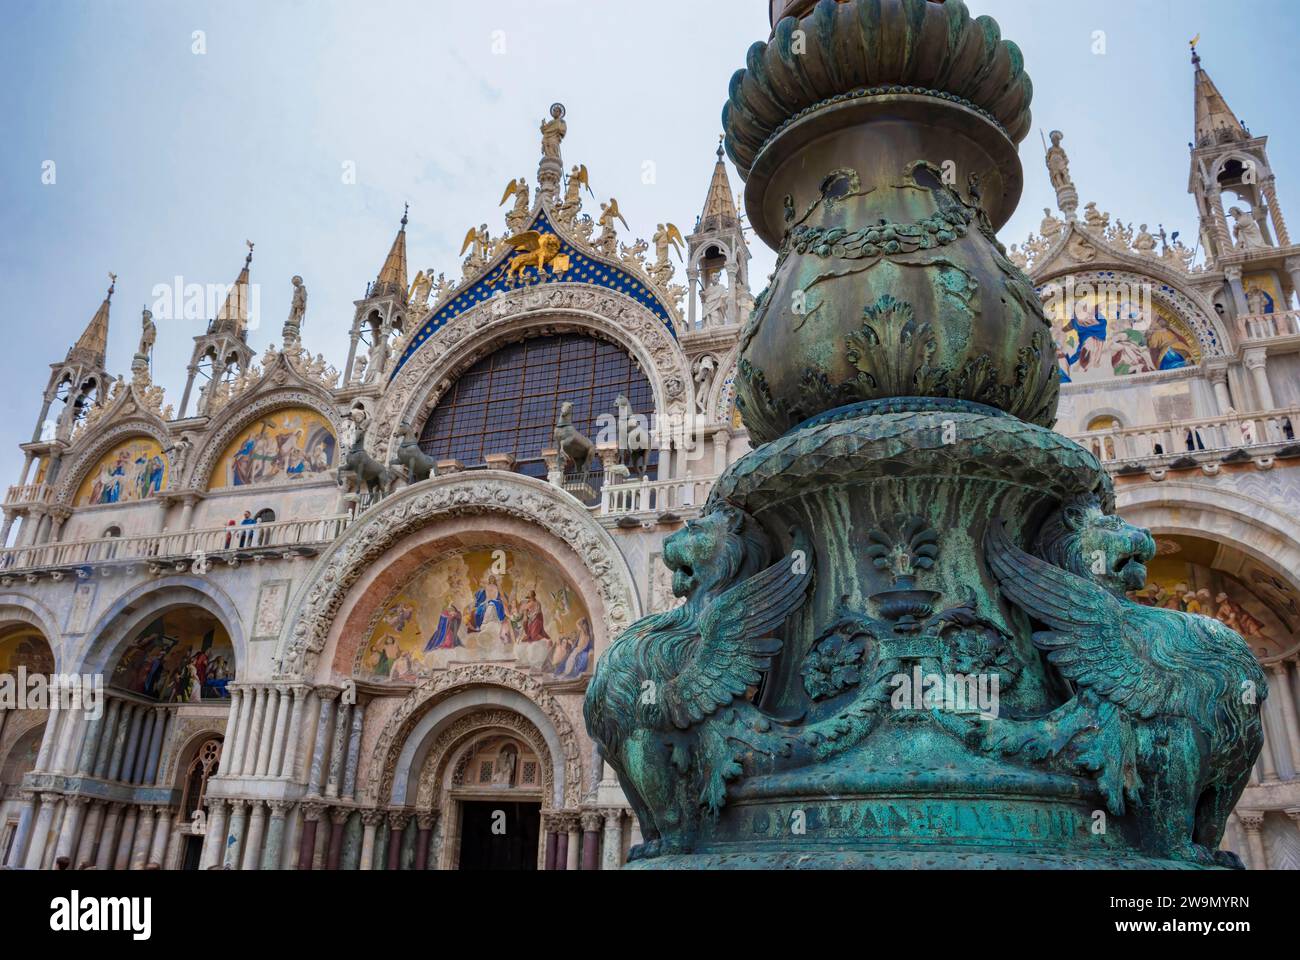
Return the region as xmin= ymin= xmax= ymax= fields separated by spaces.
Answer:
xmin=368 ymin=284 xmax=692 ymax=459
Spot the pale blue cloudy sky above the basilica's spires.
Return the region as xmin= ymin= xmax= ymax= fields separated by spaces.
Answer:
xmin=0 ymin=0 xmax=1300 ymax=489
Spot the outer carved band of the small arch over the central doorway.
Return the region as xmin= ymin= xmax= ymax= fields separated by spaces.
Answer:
xmin=371 ymin=663 xmax=582 ymax=808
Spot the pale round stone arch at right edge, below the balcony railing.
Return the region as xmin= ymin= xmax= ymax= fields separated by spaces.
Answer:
xmin=1115 ymin=480 xmax=1300 ymax=662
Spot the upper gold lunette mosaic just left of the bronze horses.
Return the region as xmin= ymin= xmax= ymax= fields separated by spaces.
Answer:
xmin=212 ymin=408 xmax=338 ymax=489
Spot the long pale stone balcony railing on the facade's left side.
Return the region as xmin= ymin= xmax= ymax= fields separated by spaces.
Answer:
xmin=0 ymin=516 xmax=350 ymax=575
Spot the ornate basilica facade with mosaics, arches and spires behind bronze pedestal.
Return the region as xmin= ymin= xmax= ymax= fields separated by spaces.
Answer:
xmin=0 ymin=50 xmax=1300 ymax=870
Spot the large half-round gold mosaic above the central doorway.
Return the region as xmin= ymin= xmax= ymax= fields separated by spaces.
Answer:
xmin=356 ymin=546 xmax=595 ymax=682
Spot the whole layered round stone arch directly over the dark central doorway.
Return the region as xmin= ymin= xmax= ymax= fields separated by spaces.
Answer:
xmin=369 ymin=663 xmax=582 ymax=809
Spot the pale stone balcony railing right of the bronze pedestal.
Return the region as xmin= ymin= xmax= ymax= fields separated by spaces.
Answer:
xmin=1070 ymin=408 xmax=1300 ymax=463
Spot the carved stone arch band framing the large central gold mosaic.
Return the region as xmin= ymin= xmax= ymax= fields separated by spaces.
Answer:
xmin=277 ymin=471 xmax=641 ymax=678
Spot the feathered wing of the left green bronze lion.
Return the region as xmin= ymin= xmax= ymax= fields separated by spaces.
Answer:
xmin=663 ymin=558 xmax=813 ymax=730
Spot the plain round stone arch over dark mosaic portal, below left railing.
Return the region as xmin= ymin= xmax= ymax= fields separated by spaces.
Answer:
xmin=73 ymin=574 xmax=248 ymax=676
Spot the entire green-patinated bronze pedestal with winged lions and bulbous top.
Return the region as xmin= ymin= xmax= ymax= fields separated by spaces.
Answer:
xmin=585 ymin=0 xmax=1266 ymax=869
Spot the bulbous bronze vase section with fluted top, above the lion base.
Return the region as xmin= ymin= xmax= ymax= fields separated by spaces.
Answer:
xmin=724 ymin=0 xmax=1058 ymax=442
